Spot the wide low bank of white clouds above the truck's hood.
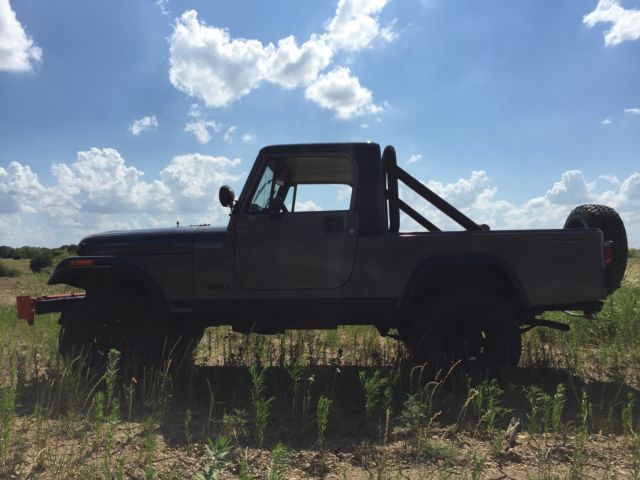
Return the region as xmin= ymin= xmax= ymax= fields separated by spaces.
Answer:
xmin=0 ymin=148 xmax=240 ymax=245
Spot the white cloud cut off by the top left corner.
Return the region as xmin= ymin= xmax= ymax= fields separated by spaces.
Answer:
xmin=0 ymin=0 xmax=42 ymax=72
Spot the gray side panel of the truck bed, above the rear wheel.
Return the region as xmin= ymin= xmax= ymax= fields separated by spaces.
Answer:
xmin=343 ymin=229 xmax=606 ymax=306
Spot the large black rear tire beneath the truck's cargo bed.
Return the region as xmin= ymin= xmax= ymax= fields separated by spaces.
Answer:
xmin=404 ymin=288 xmax=522 ymax=376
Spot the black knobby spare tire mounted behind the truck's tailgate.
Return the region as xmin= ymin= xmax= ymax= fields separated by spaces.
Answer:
xmin=564 ymin=205 xmax=629 ymax=293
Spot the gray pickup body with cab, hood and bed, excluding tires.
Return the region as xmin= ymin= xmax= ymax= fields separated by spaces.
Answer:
xmin=25 ymin=143 xmax=626 ymax=370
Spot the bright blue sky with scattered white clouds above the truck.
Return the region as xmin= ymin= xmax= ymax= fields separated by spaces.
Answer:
xmin=0 ymin=0 xmax=640 ymax=246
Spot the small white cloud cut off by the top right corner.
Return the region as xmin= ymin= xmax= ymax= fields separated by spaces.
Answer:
xmin=583 ymin=0 xmax=640 ymax=46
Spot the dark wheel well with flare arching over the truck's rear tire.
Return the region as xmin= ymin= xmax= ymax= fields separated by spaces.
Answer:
xmin=401 ymin=263 xmax=527 ymax=309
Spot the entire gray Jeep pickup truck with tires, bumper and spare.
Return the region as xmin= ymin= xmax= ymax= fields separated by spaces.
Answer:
xmin=17 ymin=143 xmax=627 ymax=368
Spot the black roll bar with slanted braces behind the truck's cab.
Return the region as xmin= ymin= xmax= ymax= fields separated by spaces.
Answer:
xmin=382 ymin=145 xmax=484 ymax=233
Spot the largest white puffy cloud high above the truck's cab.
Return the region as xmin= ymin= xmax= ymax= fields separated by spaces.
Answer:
xmin=169 ymin=0 xmax=395 ymax=118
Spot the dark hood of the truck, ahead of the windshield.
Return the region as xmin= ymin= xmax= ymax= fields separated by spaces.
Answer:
xmin=80 ymin=227 xmax=220 ymax=255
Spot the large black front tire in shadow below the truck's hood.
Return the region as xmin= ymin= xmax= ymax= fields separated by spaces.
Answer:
xmin=58 ymin=291 xmax=203 ymax=368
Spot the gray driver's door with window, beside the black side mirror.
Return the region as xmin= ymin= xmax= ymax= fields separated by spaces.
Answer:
xmin=234 ymin=156 xmax=358 ymax=290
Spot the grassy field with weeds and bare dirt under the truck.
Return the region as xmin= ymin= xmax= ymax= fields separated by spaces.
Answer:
xmin=0 ymin=258 xmax=640 ymax=480
